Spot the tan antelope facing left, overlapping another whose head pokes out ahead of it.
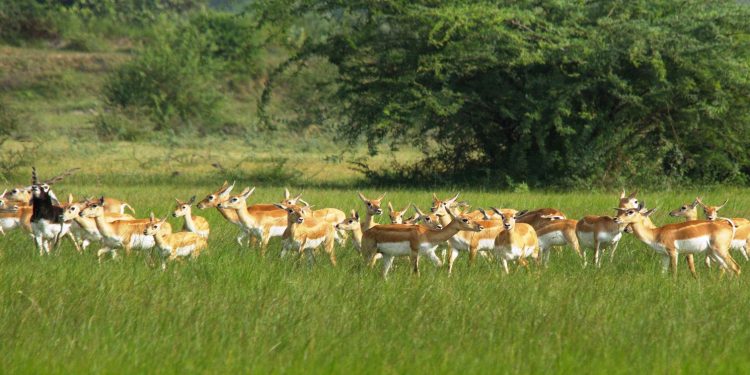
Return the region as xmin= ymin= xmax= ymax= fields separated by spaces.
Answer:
xmin=217 ymin=187 xmax=290 ymax=256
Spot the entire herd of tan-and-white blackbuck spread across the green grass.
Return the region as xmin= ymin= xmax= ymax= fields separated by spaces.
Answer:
xmin=0 ymin=169 xmax=750 ymax=277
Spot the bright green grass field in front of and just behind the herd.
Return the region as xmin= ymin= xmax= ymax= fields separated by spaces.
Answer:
xmin=0 ymin=182 xmax=750 ymax=373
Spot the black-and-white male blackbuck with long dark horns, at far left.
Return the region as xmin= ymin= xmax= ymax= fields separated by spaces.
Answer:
xmin=31 ymin=167 xmax=75 ymax=255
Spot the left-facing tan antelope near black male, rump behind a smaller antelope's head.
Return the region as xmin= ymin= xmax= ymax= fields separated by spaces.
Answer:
xmin=79 ymin=197 xmax=172 ymax=262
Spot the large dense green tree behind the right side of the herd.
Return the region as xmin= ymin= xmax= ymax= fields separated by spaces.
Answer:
xmin=262 ymin=0 xmax=750 ymax=185
